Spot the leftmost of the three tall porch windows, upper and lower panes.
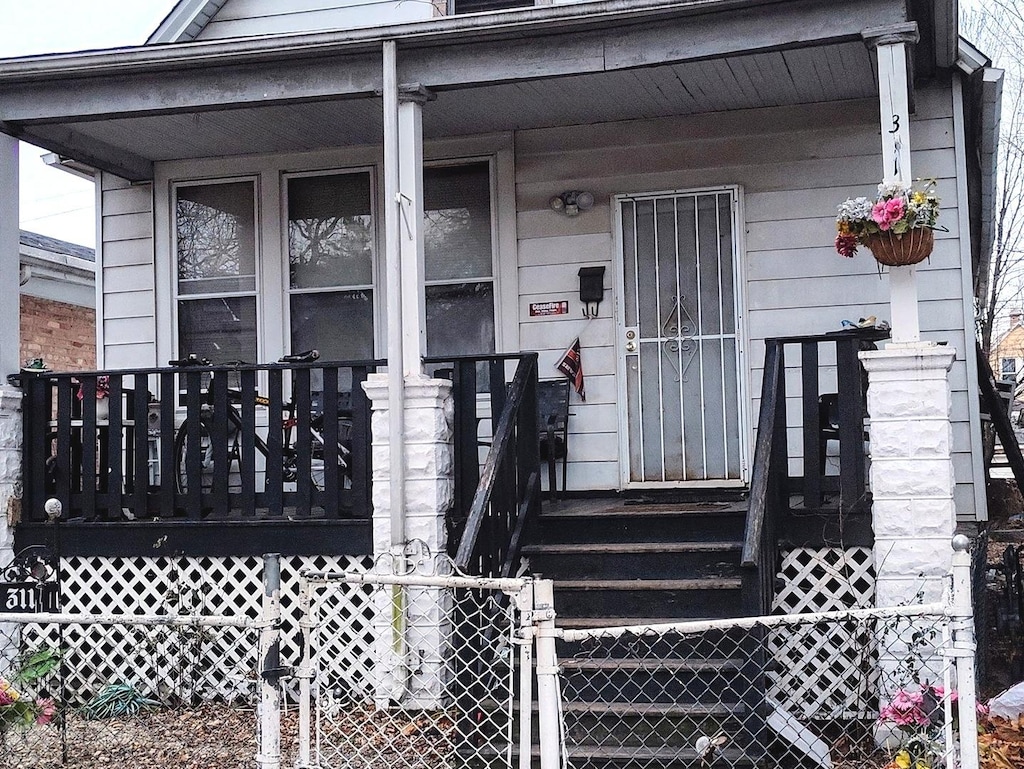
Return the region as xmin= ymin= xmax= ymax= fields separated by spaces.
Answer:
xmin=174 ymin=180 xmax=258 ymax=362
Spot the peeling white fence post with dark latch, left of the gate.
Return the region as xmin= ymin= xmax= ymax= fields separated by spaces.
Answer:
xmin=256 ymin=553 xmax=282 ymax=769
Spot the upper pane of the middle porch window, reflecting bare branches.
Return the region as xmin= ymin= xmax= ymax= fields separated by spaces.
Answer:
xmin=288 ymin=173 xmax=374 ymax=289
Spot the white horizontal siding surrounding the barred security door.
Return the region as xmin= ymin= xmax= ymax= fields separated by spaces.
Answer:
xmin=516 ymin=86 xmax=975 ymax=518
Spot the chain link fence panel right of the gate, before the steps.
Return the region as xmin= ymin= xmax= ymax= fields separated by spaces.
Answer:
xmin=559 ymin=607 xmax=973 ymax=769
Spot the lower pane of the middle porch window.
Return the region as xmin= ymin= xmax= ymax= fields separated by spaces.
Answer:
xmin=292 ymin=291 xmax=374 ymax=360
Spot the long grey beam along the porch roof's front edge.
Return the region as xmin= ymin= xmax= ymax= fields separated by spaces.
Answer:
xmin=0 ymin=0 xmax=905 ymax=125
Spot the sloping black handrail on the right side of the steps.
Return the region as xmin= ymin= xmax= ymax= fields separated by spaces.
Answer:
xmin=741 ymin=339 xmax=785 ymax=616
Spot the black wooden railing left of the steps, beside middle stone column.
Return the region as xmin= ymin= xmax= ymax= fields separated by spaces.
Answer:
xmin=427 ymin=352 xmax=541 ymax=576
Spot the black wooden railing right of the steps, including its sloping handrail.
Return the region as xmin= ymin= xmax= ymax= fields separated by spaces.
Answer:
xmin=742 ymin=329 xmax=889 ymax=615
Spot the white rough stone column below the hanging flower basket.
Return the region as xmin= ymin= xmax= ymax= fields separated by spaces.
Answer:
xmin=860 ymin=345 xmax=956 ymax=606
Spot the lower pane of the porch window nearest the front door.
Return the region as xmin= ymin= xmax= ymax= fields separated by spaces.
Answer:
xmin=427 ymin=282 xmax=495 ymax=355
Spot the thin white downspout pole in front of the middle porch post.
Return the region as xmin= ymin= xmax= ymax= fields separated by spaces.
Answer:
xmin=382 ymin=40 xmax=406 ymax=553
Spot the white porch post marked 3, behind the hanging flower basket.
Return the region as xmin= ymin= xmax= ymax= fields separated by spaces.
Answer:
xmin=861 ymin=22 xmax=921 ymax=344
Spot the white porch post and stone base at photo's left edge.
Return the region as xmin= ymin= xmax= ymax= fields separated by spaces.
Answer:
xmin=0 ymin=134 xmax=22 ymax=565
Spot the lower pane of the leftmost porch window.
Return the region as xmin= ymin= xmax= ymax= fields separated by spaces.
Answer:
xmin=178 ymin=296 xmax=256 ymax=364
